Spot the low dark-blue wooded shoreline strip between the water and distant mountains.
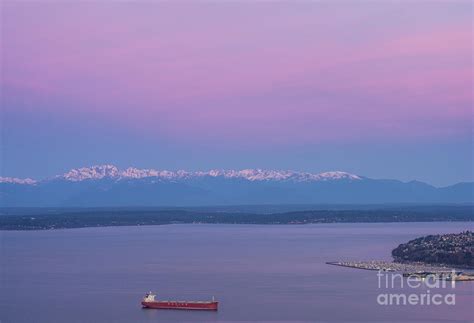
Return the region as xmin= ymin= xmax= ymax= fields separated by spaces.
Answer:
xmin=0 ymin=207 xmax=474 ymax=230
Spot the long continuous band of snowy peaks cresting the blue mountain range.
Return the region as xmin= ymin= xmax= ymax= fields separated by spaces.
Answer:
xmin=56 ymin=165 xmax=362 ymax=182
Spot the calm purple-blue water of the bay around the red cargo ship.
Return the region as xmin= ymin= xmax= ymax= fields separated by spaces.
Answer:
xmin=0 ymin=223 xmax=474 ymax=323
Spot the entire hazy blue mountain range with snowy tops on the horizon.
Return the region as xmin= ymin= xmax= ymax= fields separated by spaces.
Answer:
xmin=0 ymin=165 xmax=474 ymax=206
